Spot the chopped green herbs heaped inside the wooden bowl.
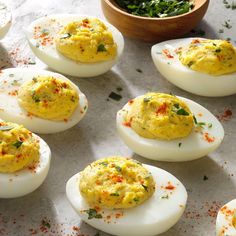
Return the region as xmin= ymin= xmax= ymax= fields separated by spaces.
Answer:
xmin=116 ymin=0 xmax=194 ymax=17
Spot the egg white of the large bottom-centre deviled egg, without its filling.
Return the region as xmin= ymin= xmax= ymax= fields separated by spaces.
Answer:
xmin=66 ymin=165 xmax=187 ymax=236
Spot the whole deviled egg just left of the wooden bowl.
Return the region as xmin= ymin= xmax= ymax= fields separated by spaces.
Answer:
xmin=26 ymin=14 xmax=124 ymax=77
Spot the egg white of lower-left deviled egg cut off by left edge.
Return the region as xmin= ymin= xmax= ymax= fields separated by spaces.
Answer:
xmin=0 ymin=134 xmax=51 ymax=198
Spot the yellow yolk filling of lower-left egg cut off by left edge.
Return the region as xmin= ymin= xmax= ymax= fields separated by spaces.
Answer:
xmin=0 ymin=122 xmax=39 ymax=173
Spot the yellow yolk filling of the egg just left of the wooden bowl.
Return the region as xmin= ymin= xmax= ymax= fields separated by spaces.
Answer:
xmin=55 ymin=19 xmax=117 ymax=63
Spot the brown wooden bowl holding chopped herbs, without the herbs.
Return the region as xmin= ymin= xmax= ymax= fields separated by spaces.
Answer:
xmin=101 ymin=0 xmax=210 ymax=42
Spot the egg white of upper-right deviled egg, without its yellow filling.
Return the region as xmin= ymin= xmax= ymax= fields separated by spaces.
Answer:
xmin=151 ymin=38 xmax=236 ymax=97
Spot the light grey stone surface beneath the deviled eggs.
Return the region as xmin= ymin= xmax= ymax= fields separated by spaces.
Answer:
xmin=0 ymin=0 xmax=236 ymax=236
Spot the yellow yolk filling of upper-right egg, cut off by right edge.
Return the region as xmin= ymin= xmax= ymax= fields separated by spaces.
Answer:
xmin=178 ymin=39 xmax=236 ymax=76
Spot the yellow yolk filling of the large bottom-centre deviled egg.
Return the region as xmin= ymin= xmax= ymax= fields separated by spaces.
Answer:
xmin=79 ymin=157 xmax=155 ymax=209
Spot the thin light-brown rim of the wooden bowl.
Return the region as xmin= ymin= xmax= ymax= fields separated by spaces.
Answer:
xmin=101 ymin=0 xmax=210 ymax=21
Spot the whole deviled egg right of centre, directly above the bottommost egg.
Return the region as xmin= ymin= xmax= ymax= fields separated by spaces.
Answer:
xmin=116 ymin=93 xmax=224 ymax=162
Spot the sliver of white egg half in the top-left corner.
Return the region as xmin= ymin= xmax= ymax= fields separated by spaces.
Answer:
xmin=0 ymin=1 xmax=11 ymax=39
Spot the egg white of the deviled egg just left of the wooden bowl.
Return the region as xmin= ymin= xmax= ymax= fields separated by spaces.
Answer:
xmin=26 ymin=14 xmax=124 ymax=77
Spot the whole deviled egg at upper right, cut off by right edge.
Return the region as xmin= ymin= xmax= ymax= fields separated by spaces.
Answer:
xmin=151 ymin=38 xmax=236 ymax=97
